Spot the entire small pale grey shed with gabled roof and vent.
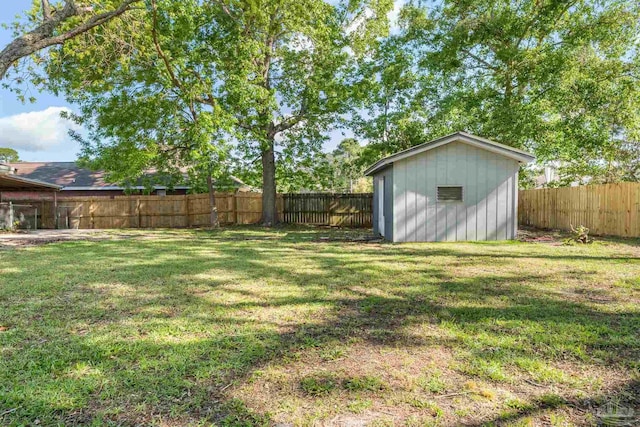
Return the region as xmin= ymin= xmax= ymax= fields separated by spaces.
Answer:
xmin=365 ymin=132 xmax=534 ymax=242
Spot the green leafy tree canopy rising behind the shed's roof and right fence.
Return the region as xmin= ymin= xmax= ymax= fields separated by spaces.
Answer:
xmin=354 ymin=0 xmax=640 ymax=184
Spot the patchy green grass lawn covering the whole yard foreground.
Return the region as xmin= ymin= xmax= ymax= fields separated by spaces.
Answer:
xmin=0 ymin=228 xmax=640 ymax=426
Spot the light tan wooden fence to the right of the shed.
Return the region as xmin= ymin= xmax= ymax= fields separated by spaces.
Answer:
xmin=518 ymin=182 xmax=640 ymax=237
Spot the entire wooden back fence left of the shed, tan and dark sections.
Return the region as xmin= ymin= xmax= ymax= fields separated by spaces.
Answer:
xmin=11 ymin=193 xmax=373 ymax=229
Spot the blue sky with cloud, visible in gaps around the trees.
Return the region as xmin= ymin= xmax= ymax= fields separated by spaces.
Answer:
xmin=0 ymin=0 xmax=404 ymax=161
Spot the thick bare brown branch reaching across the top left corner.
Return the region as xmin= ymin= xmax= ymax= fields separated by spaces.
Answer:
xmin=0 ymin=0 xmax=143 ymax=80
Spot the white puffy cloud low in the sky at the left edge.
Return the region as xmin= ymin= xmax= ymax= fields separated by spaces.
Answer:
xmin=0 ymin=107 xmax=80 ymax=152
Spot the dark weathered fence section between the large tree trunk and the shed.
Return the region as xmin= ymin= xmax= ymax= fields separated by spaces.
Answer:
xmin=282 ymin=193 xmax=373 ymax=227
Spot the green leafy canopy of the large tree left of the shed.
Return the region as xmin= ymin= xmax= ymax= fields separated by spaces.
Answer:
xmin=41 ymin=0 xmax=392 ymax=198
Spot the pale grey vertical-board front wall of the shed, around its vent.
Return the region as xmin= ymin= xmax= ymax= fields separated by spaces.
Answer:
xmin=392 ymin=142 xmax=519 ymax=242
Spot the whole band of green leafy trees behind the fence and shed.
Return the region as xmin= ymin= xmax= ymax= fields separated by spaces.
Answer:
xmin=0 ymin=0 xmax=640 ymax=224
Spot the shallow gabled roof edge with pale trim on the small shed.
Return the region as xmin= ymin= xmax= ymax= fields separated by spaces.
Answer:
xmin=364 ymin=132 xmax=535 ymax=175
